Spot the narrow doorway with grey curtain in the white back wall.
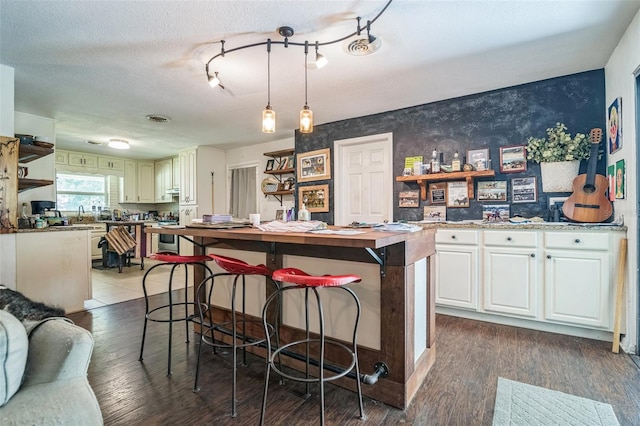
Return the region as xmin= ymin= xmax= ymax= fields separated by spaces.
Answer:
xmin=229 ymin=166 xmax=258 ymax=219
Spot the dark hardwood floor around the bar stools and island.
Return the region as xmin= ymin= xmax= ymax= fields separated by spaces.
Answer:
xmin=69 ymin=294 xmax=640 ymax=425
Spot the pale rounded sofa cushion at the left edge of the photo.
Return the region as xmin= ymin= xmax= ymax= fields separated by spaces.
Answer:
xmin=0 ymin=310 xmax=29 ymax=407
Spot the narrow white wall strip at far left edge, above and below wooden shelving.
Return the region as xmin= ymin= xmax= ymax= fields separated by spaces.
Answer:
xmin=0 ymin=64 xmax=16 ymax=290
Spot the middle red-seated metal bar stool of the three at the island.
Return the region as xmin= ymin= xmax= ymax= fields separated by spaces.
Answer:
xmin=193 ymin=254 xmax=280 ymax=417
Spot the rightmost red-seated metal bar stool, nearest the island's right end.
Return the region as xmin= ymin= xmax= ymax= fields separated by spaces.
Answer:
xmin=260 ymin=268 xmax=365 ymax=425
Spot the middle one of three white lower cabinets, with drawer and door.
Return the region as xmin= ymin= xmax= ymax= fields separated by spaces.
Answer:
xmin=483 ymin=231 xmax=539 ymax=317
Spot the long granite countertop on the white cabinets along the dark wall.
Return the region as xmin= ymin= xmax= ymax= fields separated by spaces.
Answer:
xmin=410 ymin=220 xmax=627 ymax=231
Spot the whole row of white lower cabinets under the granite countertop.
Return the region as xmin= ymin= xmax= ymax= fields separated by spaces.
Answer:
xmin=434 ymin=227 xmax=625 ymax=332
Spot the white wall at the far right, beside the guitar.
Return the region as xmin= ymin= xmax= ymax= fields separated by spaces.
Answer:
xmin=602 ymin=8 xmax=640 ymax=353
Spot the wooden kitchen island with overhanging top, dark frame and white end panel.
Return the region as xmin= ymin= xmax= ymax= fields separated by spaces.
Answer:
xmin=145 ymin=226 xmax=435 ymax=409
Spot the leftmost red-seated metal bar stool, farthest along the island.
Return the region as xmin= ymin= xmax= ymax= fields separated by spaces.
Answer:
xmin=139 ymin=252 xmax=213 ymax=376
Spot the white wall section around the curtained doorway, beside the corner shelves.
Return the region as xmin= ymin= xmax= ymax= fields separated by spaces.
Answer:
xmin=226 ymin=136 xmax=295 ymax=220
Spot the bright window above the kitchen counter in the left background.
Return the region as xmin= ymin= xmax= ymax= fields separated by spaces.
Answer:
xmin=56 ymin=173 xmax=108 ymax=211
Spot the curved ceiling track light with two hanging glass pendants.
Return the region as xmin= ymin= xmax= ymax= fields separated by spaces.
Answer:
xmin=205 ymin=0 xmax=393 ymax=133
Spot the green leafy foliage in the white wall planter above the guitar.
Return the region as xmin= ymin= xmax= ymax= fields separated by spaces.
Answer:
xmin=527 ymin=123 xmax=591 ymax=163
